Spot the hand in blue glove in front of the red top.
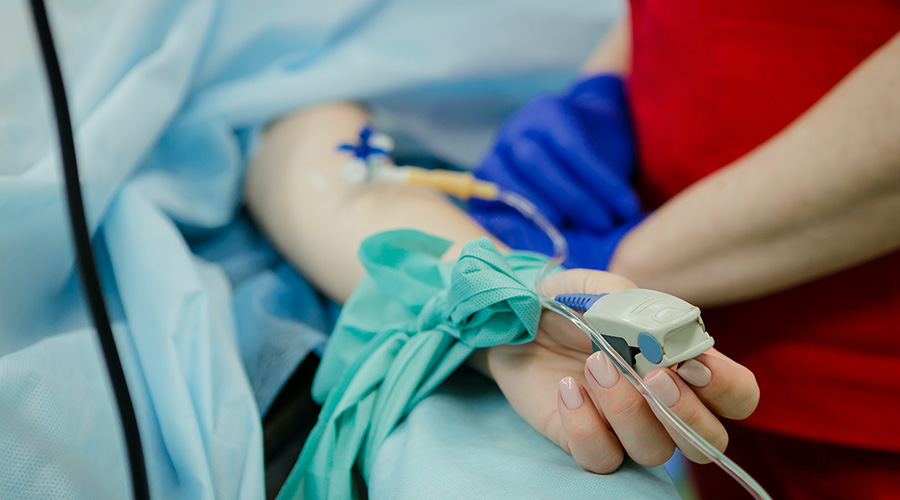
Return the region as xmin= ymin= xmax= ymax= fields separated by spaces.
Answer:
xmin=469 ymin=75 xmax=642 ymax=269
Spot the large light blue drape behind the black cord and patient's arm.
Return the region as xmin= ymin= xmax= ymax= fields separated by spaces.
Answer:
xmin=0 ymin=0 xmax=652 ymax=500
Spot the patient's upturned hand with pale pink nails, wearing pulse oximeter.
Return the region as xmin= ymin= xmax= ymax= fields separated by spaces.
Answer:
xmin=478 ymin=269 xmax=759 ymax=473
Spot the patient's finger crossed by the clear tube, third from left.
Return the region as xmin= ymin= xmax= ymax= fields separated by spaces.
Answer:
xmin=644 ymin=368 xmax=728 ymax=463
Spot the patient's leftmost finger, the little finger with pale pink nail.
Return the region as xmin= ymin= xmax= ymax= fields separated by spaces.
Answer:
xmin=557 ymin=377 xmax=625 ymax=474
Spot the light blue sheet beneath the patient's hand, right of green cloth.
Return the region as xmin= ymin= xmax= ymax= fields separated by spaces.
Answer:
xmin=369 ymin=370 xmax=680 ymax=500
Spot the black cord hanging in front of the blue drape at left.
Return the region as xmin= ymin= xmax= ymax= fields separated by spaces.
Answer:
xmin=31 ymin=0 xmax=150 ymax=500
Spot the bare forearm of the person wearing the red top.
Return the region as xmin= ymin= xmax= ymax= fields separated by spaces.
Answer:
xmin=610 ymin=35 xmax=900 ymax=305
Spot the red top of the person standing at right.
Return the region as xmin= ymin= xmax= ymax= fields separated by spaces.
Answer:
xmin=628 ymin=0 xmax=900 ymax=451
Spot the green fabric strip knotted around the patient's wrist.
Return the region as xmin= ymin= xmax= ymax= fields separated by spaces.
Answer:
xmin=278 ymin=230 xmax=547 ymax=500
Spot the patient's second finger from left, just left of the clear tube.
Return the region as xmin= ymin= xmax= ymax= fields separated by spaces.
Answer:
xmin=585 ymin=352 xmax=676 ymax=467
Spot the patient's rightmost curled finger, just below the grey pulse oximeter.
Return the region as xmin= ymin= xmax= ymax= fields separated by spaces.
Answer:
xmin=675 ymin=349 xmax=759 ymax=420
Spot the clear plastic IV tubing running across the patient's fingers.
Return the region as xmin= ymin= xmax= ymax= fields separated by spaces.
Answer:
xmin=496 ymin=189 xmax=772 ymax=500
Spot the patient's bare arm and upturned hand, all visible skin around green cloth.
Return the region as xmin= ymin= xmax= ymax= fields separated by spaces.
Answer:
xmin=246 ymin=103 xmax=759 ymax=473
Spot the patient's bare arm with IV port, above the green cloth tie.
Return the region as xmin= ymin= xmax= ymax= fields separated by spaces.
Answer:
xmin=246 ymin=104 xmax=496 ymax=301
